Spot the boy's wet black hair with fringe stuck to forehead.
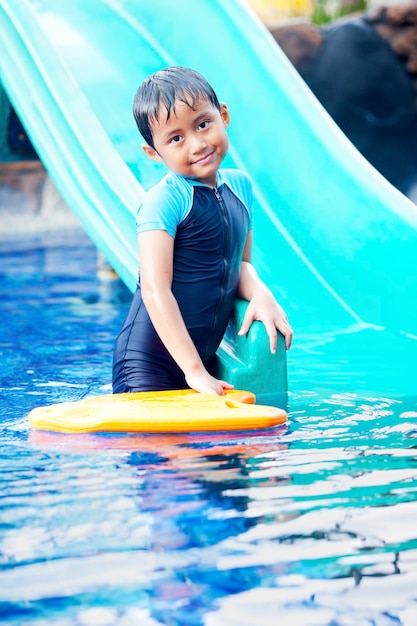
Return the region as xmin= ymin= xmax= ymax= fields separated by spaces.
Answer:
xmin=133 ymin=66 xmax=220 ymax=148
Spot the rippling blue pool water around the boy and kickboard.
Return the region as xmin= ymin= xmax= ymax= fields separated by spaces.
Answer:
xmin=0 ymin=233 xmax=417 ymax=626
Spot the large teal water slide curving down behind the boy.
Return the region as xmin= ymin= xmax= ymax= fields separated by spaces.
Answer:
xmin=0 ymin=0 xmax=417 ymax=395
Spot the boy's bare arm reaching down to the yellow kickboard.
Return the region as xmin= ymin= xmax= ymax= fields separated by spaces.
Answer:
xmin=139 ymin=230 xmax=232 ymax=395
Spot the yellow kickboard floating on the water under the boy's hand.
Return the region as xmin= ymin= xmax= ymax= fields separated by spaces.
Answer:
xmin=29 ymin=389 xmax=287 ymax=433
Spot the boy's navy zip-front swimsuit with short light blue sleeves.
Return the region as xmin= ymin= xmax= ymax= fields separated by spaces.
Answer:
xmin=113 ymin=169 xmax=253 ymax=393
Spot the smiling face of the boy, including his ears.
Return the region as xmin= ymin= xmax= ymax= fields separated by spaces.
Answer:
xmin=142 ymin=98 xmax=230 ymax=187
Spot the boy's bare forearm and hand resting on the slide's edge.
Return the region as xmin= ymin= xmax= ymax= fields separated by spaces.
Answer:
xmin=238 ymin=231 xmax=293 ymax=353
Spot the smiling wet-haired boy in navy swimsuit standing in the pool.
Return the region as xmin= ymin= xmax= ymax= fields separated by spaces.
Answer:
xmin=113 ymin=67 xmax=292 ymax=395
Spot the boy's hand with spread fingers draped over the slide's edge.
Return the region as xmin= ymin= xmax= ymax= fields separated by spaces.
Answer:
xmin=238 ymin=287 xmax=293 ymax=354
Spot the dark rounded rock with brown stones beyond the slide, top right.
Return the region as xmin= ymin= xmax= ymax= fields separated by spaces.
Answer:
xmin=270 ymin=5 xmax=417 ymax=197
